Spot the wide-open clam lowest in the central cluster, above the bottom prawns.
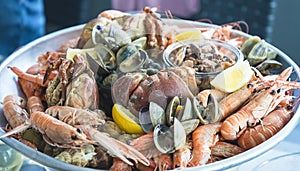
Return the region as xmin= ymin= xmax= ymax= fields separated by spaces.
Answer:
xmin=153 ymin=118 xmax=186 ymax=153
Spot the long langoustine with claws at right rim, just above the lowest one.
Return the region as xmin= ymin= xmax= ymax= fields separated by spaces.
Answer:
xmin=221 ymin=67 xmax=300 ymax=140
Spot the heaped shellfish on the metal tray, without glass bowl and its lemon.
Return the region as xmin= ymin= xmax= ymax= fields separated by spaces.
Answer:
xmin=0 ymin=7 xmax=300 ymax=170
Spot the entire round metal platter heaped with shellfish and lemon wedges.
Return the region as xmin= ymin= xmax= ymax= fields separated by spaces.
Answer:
xmin=0 ymin=7 xmax=300 ymax=171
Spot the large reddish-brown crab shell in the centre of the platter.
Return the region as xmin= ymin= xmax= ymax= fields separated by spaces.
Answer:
xmin=112 ymin=66 xmax=193 ymax=117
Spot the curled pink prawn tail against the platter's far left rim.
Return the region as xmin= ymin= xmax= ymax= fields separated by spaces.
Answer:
xmin=3 ymin=94 xmax=29 ymax=128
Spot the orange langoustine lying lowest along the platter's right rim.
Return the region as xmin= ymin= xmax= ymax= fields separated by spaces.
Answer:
xmin=238 ymin=106 xmax=293 ymax=149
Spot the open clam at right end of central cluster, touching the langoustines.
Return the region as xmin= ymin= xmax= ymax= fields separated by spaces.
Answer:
xmin=193 ymin=94 xmax=220 ymax=124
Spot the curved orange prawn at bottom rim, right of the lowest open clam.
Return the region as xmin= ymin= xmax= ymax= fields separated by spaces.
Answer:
xmin=188 ymin=122 xmax=221 ymax=167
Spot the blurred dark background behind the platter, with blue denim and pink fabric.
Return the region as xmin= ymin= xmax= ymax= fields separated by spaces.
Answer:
xmin=0 ymin=0 xmax=300 ymax=65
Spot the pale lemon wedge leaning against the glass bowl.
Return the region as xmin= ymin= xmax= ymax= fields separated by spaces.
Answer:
xmin=210 ymin=60 xmax=253 ymax=93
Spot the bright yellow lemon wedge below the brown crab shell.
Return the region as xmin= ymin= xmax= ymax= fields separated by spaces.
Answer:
xmin=112 ymin=104 xmax=144 ymax=134
